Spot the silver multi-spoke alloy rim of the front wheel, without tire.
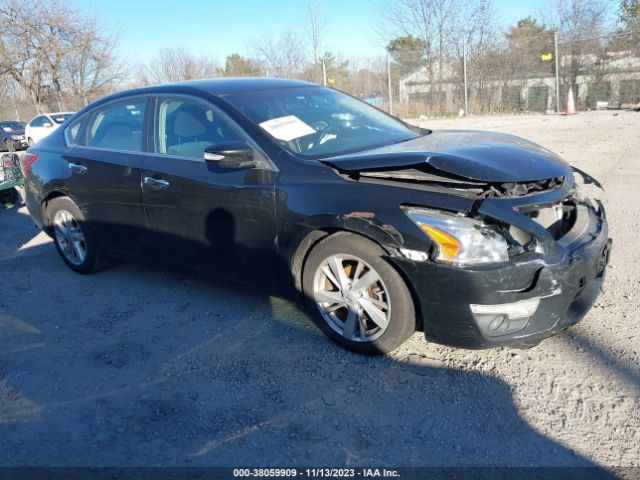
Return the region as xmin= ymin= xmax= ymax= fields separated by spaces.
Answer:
xmin=313 ymin=254 xmax=391 ymax=342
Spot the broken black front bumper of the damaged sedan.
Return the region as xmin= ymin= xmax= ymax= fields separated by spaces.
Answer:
xmin=392 ymin=184 xmax=611 ymax=348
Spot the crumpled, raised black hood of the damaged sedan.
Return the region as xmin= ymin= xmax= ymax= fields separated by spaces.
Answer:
xmin=323 ymin=130 xmax=571 ymax=182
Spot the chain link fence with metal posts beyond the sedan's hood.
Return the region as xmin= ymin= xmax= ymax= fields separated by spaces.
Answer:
xmin=390 ymin=32 xmax=640 ymax=117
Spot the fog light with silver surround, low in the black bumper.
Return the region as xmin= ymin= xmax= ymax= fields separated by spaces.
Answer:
xmin=470 ymin=298 xmax=540 ymax=337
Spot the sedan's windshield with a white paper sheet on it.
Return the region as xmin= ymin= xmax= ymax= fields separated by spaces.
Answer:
xmin=225 ymin=87 xmax=420 ymax=158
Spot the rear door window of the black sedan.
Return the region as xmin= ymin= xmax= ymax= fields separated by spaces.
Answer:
xmin=85 ymin=97 xmax=146 ymax=152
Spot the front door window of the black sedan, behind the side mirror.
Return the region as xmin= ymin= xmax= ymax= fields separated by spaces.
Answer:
xmin=155 ymin=98 xmax=241 ymax=158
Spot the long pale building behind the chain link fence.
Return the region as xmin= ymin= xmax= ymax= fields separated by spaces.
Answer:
xmin=399 ymin=51 xmax=640 ymax=114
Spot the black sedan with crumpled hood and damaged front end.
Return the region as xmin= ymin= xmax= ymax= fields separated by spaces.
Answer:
xmin=22 ymin=79 xmax=610 ymax=353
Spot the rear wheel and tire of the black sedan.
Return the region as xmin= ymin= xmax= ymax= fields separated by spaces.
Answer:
xmin=47 ymin=197 xmax=106 ymax=274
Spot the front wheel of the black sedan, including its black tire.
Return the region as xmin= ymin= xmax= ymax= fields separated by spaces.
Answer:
xmin=302 ymin=232 xmax=416 ymax=355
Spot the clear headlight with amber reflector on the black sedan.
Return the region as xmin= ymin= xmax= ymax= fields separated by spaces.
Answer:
xmin=405 ymin=208 xmax=509 ymax=265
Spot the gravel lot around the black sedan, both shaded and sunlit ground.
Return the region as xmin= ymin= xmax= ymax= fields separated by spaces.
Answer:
xmin=0 ymin=112 xmax=640 ymax=466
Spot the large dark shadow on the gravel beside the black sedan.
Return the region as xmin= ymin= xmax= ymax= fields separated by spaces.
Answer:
xmin=0 ymin=205 xmax=608 ymax=478
